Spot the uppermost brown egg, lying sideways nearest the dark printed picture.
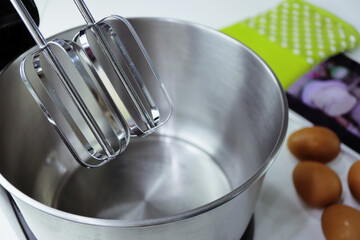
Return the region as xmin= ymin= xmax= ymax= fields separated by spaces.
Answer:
xmin=287 ymin=126 xmax=341 ymax=163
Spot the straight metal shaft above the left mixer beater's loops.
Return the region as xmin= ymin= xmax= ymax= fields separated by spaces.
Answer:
xmin=10 ymin=0 xmax=47 ymax=49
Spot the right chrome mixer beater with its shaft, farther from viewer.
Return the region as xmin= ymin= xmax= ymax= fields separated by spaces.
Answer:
xmin=74 ymin=0 xmax=171 ymax=136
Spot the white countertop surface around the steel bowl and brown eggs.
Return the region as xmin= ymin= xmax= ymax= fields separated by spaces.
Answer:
xmin=0 ymin=0 xmax=360 ymax=240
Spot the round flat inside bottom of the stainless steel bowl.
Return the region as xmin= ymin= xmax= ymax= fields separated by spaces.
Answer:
xmin=53 ymin=135 xmax=231 ymax=220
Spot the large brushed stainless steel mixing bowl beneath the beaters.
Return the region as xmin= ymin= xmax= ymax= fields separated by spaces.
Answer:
xmin=0 ymin=18 xmax=287 ymax=240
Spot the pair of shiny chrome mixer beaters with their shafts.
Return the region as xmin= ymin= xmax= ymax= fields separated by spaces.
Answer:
xmin=10 ymin=0 xmax=172 ymax=167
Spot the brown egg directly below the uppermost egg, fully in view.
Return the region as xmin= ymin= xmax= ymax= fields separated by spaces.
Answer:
xmin=293 ymin=161 xmax=342 ymax=208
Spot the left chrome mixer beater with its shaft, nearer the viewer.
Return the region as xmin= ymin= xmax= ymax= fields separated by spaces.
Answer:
xmin=11 ymin=0 xmax=130 ymax=167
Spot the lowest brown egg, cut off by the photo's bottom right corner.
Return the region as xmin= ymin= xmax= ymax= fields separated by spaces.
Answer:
xmin=321 ymin=204 xmax=360 ymax=240
